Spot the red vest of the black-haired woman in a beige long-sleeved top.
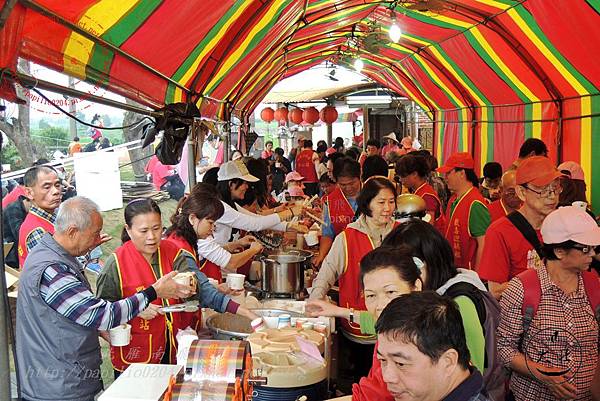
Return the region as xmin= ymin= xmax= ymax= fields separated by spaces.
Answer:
xmin=338 ymin=227 xmax=375 ymax=340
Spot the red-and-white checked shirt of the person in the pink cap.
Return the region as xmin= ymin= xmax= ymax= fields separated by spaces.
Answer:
xmin=498 ymin=265 xmax=600 ymax=401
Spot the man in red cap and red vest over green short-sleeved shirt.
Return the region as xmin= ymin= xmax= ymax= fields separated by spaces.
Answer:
xmin=437 ymin=152 xmax=490 ymax=270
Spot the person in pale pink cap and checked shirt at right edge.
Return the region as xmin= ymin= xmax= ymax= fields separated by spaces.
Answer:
xmin=497 ymin=206 xmax=600 ymax=401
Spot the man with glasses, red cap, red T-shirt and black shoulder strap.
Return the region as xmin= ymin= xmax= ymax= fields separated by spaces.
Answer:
xmin=478 ymin=156 xmax=561 ymax=299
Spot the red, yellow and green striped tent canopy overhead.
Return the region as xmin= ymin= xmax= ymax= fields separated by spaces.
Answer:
xmin=0 ymin=0 xmax=600 ymax=206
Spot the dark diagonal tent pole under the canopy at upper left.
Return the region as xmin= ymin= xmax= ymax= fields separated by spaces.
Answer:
xmin=20 ymin=0 xmax=191 ymax=93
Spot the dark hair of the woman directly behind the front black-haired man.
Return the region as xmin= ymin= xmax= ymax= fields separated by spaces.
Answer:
xmin=360 ymin=245 xmax=421 ymax=286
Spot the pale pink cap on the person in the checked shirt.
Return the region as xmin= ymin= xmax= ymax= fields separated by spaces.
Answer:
xmin=540 ymin=206 xmax=600 ymax=246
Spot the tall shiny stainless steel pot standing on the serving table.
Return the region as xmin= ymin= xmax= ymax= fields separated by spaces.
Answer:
xmin=261 ymin=251 xmax=306 ymax=295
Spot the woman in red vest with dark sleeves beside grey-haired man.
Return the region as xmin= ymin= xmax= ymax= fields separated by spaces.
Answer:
xmin=97 ymin=199 xmax=257 ymax=376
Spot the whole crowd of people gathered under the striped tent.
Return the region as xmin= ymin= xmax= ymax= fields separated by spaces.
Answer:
xmin=5 ymin=130 xmax=600 ymax=401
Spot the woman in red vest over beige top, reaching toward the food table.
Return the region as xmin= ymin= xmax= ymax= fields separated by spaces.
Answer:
xmin=310 ymin=176 xmax=396 ymax=390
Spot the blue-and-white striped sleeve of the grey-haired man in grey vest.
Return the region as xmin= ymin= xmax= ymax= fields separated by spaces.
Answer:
xmin=40 ymin=263 xmax=156 ymax=330
